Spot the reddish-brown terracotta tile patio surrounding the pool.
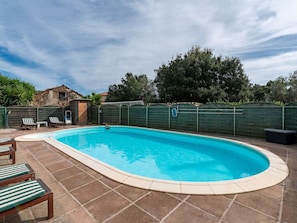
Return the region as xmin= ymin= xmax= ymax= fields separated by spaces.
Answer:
xmin=0 ymin=128 xmax=297 ymax=223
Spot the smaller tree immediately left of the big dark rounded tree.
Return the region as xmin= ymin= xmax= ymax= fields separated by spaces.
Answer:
xmin=106 ymin=73 xmax=156 ymax=104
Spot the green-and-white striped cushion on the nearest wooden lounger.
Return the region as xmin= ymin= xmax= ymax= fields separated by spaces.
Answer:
xmin=0 ymin=180 xmax=46 ymax=212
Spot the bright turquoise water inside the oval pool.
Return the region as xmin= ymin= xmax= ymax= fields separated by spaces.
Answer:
xmin=55 ymin=126 xmax=269 ymax=182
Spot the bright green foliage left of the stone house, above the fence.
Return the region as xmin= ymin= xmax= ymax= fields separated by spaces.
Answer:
xmin=0 ymin=74 xmax=36 ymax=106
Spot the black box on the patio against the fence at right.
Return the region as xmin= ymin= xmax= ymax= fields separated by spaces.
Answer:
xmin=264 ymin=129 xmax=296 ymax=145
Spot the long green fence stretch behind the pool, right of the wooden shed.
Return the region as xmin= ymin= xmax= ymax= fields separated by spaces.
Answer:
xmin=97 ymin=103 xmax=297 ymax=137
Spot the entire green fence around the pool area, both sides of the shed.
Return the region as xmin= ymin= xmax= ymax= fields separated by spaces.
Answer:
xmin=0 ymin=103 xmax=297 ymax=137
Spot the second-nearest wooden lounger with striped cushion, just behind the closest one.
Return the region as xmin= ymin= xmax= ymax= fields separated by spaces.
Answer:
xmin=0 ymin=163 xmax=35 ymax=187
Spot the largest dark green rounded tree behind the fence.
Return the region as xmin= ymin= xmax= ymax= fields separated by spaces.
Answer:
xmin=155 ymin=47 xmax=250 ymax=103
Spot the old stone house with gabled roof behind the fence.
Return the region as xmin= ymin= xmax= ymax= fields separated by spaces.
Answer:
xmin=32 ymin=85 xmax=84 ymax=107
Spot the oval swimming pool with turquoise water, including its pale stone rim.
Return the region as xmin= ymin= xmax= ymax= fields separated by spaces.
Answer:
xmin=16 ymin=126 xmax=288 ymax=194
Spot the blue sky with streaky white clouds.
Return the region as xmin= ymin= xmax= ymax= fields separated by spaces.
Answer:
xmin=0 ymin=0 xmax=297 ymax=95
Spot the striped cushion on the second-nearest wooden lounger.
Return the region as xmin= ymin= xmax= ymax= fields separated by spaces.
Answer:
xmin=0 ymin=163 xmax=30 ymax=181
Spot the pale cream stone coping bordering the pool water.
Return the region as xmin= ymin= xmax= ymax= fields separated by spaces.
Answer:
xmin=16 ymin=128 xmax=289 ymax=195
